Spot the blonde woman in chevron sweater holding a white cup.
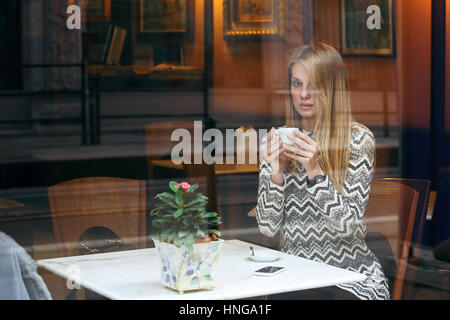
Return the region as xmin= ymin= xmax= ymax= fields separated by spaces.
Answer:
xmin=256 ymin=43 xmax=389 ymax=299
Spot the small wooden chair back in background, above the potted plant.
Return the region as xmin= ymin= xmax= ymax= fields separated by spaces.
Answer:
xmin=145 ymin=121 xmax=194 ymax=179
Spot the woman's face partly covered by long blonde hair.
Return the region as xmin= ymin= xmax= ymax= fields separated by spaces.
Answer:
xmin=291 ymin=62 xmax=318 ymax=121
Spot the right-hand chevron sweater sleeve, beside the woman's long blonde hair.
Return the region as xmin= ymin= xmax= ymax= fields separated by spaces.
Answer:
xmin=307 ymin=126 xmax=375 ymax=237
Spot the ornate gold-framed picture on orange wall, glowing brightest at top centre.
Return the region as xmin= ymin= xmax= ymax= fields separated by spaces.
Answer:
xmin=223 ymin=0 xmax=288 ymax=41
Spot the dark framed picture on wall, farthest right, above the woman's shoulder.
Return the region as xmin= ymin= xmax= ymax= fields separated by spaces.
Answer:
xmin=340 ymin=0 xmax=395 ymax=57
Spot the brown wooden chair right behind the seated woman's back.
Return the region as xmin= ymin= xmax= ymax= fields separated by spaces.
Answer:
xmin=364 ymin=179 xmax=425 ymax=300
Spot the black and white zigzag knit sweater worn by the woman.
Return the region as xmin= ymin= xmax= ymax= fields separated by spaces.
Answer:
xmin=256 ymin=123 xmax=389 ymax=300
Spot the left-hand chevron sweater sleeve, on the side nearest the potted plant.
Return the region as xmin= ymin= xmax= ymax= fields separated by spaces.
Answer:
xmin=256 ymin=134 xmax=285 ymax=237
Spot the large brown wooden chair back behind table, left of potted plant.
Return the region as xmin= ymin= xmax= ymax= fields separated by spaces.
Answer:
xmin=47 ymin=177 xmax=146 ymax=256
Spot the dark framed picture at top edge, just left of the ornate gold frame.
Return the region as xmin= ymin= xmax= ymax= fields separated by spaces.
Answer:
xmin=139 ymin=0 xmax=192 ymax=34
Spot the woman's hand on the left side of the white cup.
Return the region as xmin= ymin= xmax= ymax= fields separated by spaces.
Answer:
xmin=261 ymin=128 xmax=286 ymax=185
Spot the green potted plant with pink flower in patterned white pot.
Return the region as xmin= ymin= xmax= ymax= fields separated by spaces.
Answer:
xmin=150 ymin=181 xmax=223 ymax=293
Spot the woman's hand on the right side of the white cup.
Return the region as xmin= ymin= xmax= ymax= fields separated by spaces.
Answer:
xmin=283 ymin=130 xmax=325 ymax=179
